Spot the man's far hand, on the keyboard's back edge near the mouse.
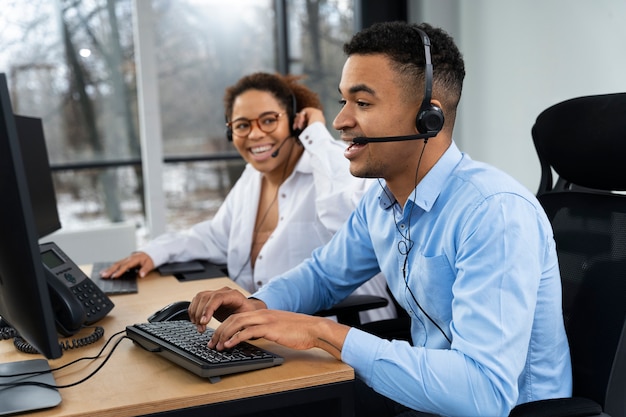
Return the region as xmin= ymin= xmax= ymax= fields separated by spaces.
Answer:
xmin=189 ymin=287 xmax=266 ymax=332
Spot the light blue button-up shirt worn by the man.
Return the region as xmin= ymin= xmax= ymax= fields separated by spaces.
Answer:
xmin=254 ymin=143 xmax=572 ymax=416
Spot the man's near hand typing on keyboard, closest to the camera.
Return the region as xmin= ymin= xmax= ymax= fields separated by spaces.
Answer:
xmin=209 ymin=309 xmax=350 ymax=360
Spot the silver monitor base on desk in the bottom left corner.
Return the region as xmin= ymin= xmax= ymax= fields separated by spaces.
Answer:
xmin=0 ymin=359 xmax=61 ymax=416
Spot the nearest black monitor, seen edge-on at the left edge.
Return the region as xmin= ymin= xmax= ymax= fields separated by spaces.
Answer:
xmin=0 ymin=74 xmax=62 ymax=359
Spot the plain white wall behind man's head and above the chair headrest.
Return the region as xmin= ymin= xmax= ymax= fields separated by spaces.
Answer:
xmin=410 ymin=0 xmax=626 ymax=192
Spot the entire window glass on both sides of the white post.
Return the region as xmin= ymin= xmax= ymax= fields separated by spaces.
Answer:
xmin=0 ymin=0 xmax=353 ymax=242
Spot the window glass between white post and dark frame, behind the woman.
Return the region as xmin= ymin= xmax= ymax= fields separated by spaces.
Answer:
xmin=152 ymin=0 xmax=276 ymax=234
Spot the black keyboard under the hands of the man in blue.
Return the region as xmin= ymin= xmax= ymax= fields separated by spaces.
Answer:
xmin=126 ymin=320 xmax=283 ymax=378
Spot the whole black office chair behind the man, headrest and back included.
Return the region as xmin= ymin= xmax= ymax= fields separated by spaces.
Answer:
xmin=510 ymin=93 xmax=626 ymax=417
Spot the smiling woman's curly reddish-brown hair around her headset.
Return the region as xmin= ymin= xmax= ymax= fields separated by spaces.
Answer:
xmin=224 ymin=72 xmax=323 ymax=119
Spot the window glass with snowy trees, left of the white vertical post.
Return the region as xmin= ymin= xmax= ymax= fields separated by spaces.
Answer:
xmin=0 ymin=0 xmax=142 ymax=234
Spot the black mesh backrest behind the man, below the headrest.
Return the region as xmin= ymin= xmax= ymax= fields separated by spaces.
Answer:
xmin=539 ymin=191 xmax=626 ymax=416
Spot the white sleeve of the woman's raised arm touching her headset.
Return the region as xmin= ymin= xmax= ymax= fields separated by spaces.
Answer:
xmin=299 ymin=122 xmax=371 ymax=233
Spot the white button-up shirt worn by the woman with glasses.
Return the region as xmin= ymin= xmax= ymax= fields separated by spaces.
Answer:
xmin=139 ymin=122 xmax=396 ymax=322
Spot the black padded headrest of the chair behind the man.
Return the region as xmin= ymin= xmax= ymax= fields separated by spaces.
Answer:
xmin=532 ymin=93 xmax=626 ymax=191
